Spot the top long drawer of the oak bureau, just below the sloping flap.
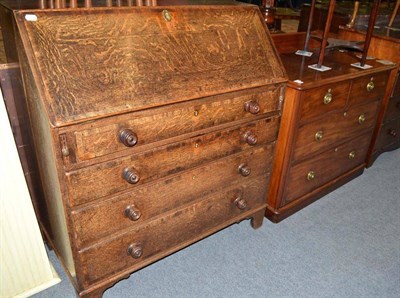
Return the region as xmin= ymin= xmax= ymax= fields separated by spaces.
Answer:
xmin=67 ymin=86 xmax=281 ymax=163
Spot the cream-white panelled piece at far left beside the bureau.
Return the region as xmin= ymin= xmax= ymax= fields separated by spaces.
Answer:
xmin=0 ymin=90 xmax=60 ymax=298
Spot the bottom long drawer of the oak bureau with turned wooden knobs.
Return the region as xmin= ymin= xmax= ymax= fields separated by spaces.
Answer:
xmin=79 ymin=176 xmax=267 ymax=283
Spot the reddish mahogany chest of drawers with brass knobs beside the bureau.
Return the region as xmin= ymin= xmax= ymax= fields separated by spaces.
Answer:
xmin=266 ymin=51 xmax=394 ymax=222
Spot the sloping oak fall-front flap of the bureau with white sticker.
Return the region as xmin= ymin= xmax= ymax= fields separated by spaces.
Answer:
xmin=16 ymin=6 xmax=285 ymax=127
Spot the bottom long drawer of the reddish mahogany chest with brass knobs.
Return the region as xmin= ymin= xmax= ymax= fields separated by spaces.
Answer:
xmin=284 ymin=133 xmax=371 ymax=204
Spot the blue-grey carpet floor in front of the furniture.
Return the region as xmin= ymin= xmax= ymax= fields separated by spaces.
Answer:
xmin=34 ymin=150 xmax=400 ymax=298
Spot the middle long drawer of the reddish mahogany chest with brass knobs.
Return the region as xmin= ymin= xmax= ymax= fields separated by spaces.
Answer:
xmin=293 ymin=101 xmax=380 ymax=162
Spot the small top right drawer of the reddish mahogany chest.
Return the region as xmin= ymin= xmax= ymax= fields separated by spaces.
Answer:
xmin=349 ymin=72 xmax=389 ymax=105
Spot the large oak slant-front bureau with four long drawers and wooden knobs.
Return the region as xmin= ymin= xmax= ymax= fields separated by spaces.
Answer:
xmin=11 ymin=5 xmax=286 ymax=297
